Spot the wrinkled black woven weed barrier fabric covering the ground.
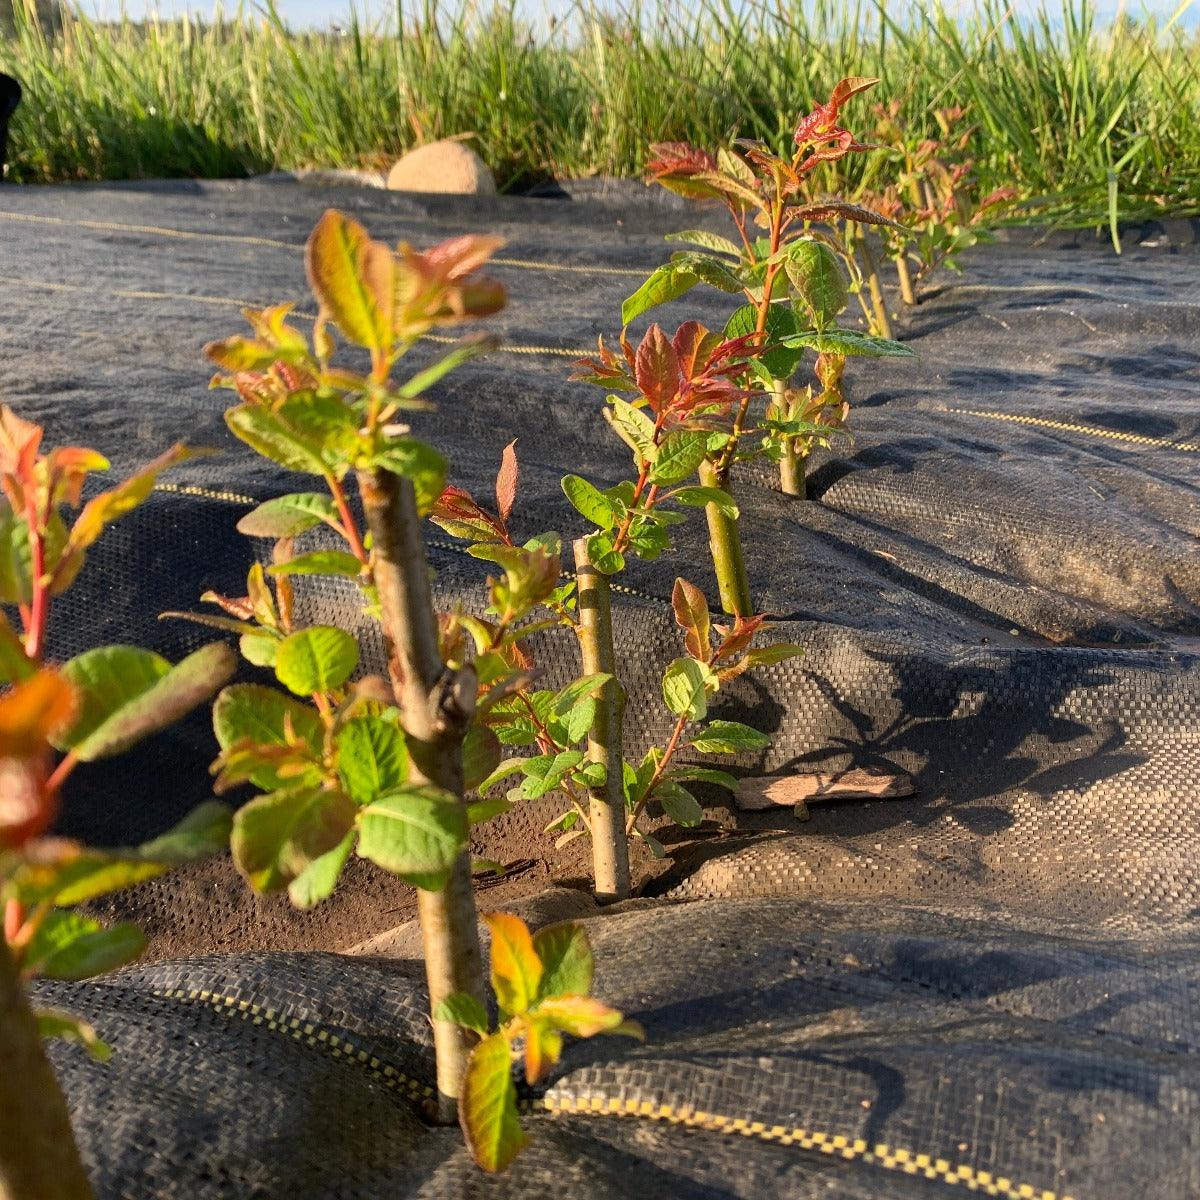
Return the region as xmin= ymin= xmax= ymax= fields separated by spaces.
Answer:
xmin=0 ymin=182 xmax=1200 ymax=1200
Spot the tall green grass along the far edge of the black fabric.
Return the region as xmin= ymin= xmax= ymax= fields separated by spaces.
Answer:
xmin=0 ymin=0 xmax=1200 ymax=223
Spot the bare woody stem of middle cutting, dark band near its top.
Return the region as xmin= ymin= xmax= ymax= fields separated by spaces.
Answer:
xmin=575 ymin=538 xmax=629 ymax=900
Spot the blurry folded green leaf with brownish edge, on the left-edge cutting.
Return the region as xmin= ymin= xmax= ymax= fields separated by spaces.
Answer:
xmin=55 ymin=642 xmax=238 ymax=762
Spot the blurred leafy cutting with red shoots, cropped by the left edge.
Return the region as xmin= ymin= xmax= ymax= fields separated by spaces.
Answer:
xmin=0 ymin=415 xmax=235 ymax=1200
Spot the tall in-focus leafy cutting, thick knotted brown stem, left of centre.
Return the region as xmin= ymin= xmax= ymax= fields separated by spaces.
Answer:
xmin=182 ymin=211 xmax=622 ymax=1169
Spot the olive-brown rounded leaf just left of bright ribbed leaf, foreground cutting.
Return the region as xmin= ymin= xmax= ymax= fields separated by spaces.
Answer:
xmin=229 ymin=787 xmax=358 ymax=892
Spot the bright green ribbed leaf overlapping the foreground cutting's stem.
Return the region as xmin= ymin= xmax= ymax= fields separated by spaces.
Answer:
xmin=359 ymin=787 xmax=469 ymax=892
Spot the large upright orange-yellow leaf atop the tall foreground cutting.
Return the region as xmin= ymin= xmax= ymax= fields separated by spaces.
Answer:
xmin=305 ymin=209 xmax=396 ymax=353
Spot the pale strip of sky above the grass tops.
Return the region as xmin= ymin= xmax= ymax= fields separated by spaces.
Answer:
xmin=85 ymin=0 xmax=1200 ymax=29
